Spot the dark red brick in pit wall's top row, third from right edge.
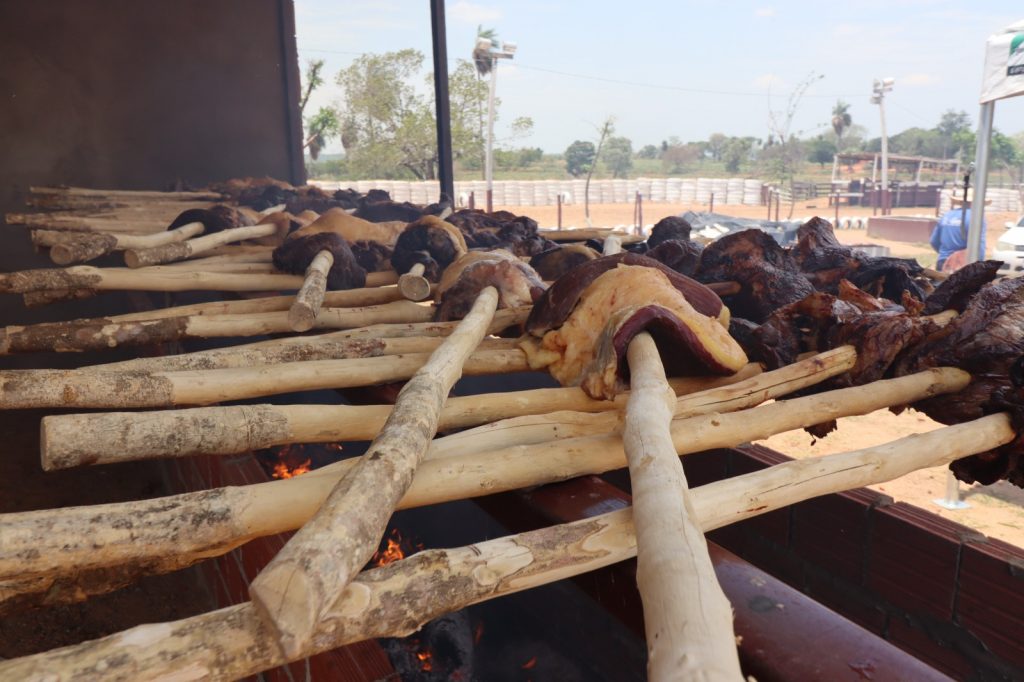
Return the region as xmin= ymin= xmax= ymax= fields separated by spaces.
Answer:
xmin=792 ymin=495 xmax=870 ymax=585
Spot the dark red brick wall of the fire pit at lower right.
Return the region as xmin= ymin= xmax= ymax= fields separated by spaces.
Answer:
xmin=683 ymin=446 xmax=1024 ymax=679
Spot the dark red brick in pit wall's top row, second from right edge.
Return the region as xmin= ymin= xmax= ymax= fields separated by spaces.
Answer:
xmin=867 ymin=503 xmax=980 ymax=621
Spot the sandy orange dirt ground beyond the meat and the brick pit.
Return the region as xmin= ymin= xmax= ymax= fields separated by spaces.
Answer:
xmin=499 ymin=199 xmax=1024 ymax=547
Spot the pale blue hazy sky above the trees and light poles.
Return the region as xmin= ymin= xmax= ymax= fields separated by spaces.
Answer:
xmin=295 ymin=0 xmax=1024 ymax=154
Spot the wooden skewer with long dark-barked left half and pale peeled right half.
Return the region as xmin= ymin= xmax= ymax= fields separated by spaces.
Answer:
xmin=0 ymin=301 xmax=433 ymax=358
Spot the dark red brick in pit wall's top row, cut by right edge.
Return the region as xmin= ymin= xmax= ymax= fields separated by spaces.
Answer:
xmin=956 ymin=540 xmax=1024 ymax=667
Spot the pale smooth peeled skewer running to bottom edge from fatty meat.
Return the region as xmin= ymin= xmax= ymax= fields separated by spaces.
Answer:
xmin=623 ymin=332 xmax=743 ymax=682
